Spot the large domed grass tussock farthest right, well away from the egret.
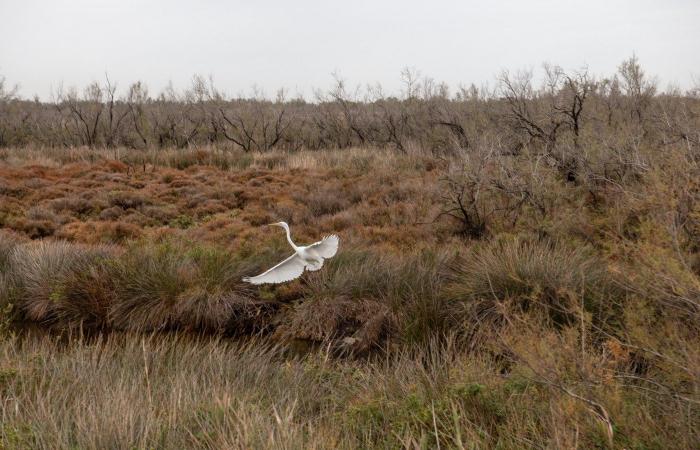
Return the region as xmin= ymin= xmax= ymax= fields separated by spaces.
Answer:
xmin=448 ymin=238 xmax=612 ymax=334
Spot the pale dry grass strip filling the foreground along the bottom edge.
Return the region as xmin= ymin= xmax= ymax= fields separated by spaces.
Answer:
xmin=0 ymin=335 xmax=697 ymax=448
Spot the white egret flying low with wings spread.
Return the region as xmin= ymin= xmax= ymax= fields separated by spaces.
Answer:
xmin=243 ymin=222 xmax=340 ymax=284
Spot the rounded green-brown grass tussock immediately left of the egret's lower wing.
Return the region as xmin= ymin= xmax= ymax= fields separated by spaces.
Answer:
xmin=109 ymin=241 xmax=258 ymax=332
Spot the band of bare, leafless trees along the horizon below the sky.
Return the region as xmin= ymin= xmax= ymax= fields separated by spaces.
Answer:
xmin=0 ymin=57 xmax=700 ymax=158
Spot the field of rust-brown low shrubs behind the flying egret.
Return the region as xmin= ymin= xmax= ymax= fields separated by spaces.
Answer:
xmin=0 ymin=151 xmax=440 ymax=248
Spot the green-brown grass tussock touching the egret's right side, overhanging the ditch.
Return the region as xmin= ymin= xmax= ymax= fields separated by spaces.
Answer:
xmin=283 ymin=250 xmax=451 ymax=351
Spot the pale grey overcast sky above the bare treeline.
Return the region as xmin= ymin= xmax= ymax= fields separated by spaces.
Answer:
xmin=0 ymin=0 xmax=700 ymax=98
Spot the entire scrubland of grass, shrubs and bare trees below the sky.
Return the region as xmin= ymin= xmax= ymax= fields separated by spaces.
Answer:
xmin=0 ymin=60 xmax=700 ymax=449
